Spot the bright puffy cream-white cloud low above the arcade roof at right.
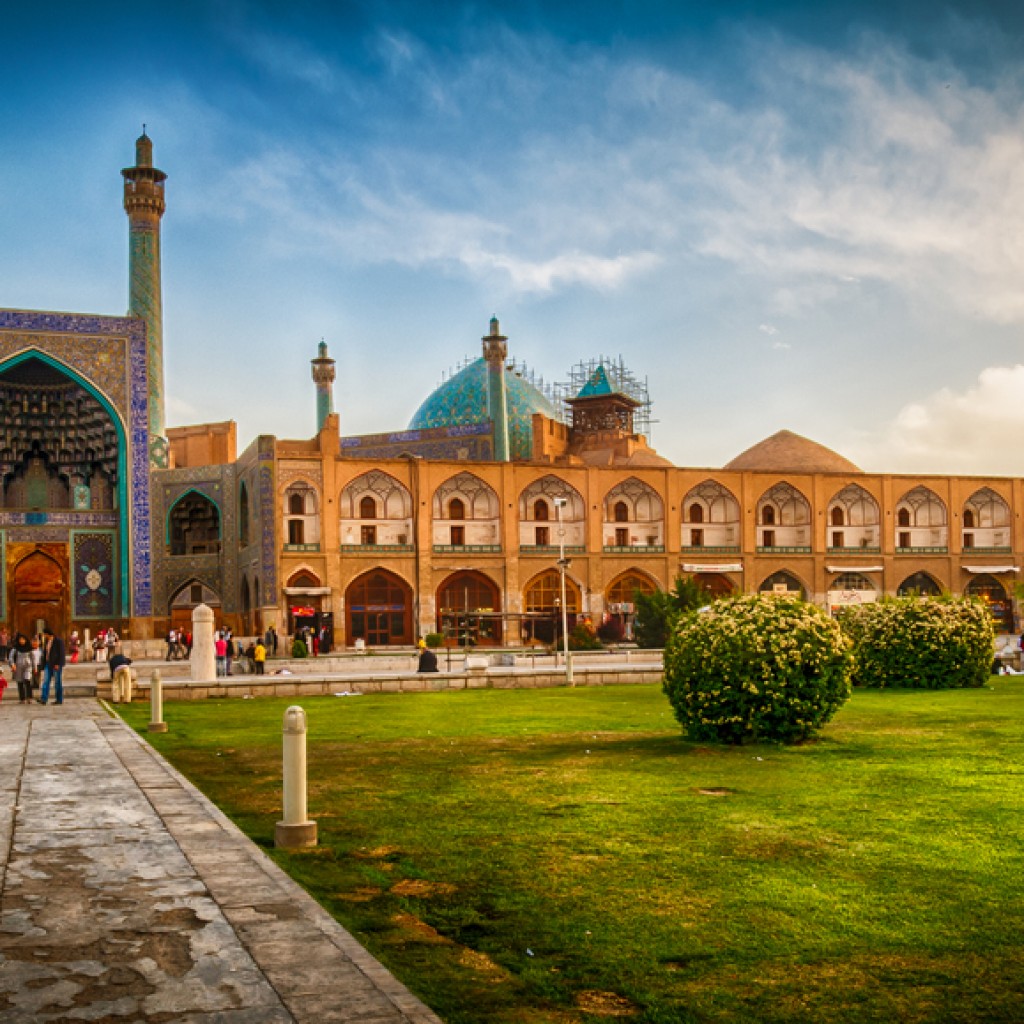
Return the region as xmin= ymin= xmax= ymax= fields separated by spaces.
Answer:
xmin=843 ymin=364 xmax=1024 ymax=475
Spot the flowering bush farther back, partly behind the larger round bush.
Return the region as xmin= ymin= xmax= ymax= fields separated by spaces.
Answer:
xmin=840 ymin=596 xmax=995 ymax=690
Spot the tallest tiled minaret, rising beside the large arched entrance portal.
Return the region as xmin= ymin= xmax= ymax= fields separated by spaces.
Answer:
xmin=121 ymin=125 xmax=167 ymax=467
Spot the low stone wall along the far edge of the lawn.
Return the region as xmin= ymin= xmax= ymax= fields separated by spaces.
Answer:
xmin=98 ymin=663 xmax=662 ymax=701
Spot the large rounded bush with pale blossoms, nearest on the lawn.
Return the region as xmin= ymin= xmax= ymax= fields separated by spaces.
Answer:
xmin=665 ymin=594 xmax=851 ymax=743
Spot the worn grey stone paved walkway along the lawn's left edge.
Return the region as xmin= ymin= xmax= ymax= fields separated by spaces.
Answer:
xmin=0 ymin=704 xmax=439 ymax=1024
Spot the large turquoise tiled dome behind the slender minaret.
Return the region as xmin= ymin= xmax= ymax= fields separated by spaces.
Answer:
xmin=409 ymin=356 xmax=557 ymax=460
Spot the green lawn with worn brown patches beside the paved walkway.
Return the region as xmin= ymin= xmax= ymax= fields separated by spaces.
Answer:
xmin=117 ymin=677 xmax=1024 ymax=1024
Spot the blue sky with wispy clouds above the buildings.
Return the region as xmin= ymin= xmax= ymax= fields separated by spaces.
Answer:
xmin=6 ymin=0 xmax=1024 ymax=474
